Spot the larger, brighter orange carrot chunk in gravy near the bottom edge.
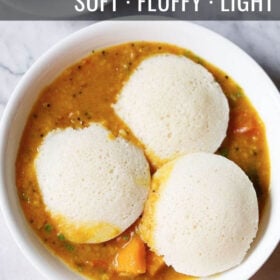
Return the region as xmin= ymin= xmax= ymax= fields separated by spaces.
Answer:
xmin=114 ymin=234 xmax=146 ymax=275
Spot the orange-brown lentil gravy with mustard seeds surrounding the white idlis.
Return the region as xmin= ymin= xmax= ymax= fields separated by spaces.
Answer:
xmin=16 ymin=42 xmax=270 ymax=280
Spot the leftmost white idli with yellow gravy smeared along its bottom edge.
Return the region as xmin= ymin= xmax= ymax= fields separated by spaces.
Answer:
xmin=35 ymin=124 xmax=150 ymax=243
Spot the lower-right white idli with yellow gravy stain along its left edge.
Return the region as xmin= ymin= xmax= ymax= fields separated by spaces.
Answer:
xmin=140 ymin=153 xmax=258 ymax=277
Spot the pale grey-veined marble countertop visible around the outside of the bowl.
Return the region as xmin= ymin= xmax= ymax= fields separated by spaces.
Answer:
xmin=0 ymin=21 xmax=280 ymax=280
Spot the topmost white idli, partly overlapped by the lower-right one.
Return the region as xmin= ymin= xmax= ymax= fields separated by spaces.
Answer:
xmin=113 ymin=54 xmax=229 ymax=166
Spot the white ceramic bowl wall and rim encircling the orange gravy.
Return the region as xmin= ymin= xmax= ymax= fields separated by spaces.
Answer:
xmin=0 ymin=21 xmax=280 ymax=280
